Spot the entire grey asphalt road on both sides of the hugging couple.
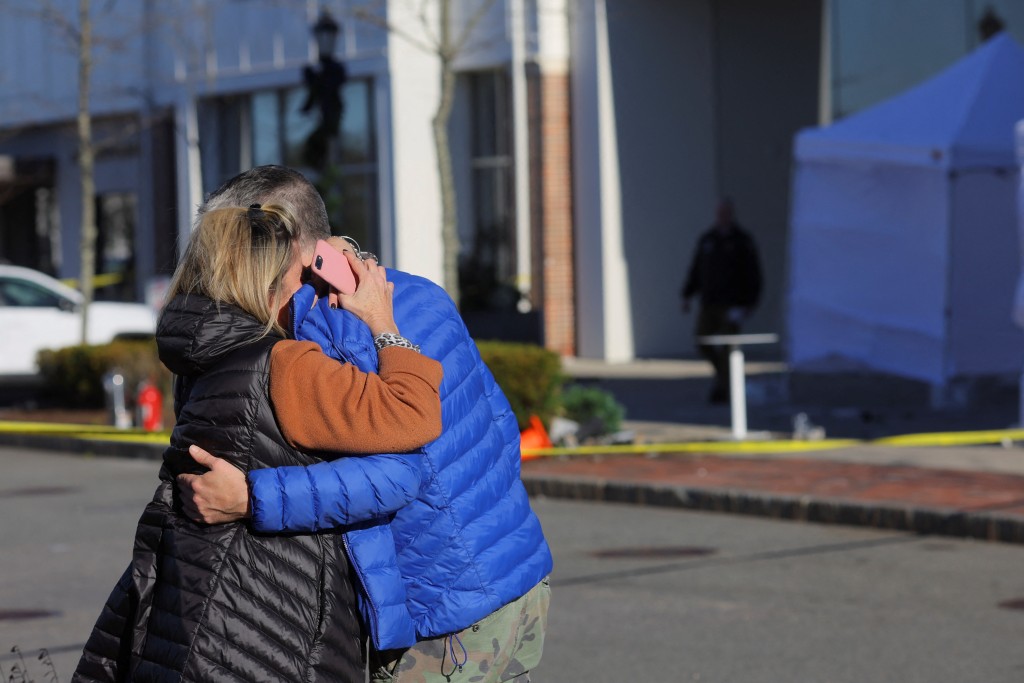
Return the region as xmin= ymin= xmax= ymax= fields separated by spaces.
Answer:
xmin=0 ymin=449 xmax=1024 ymax=683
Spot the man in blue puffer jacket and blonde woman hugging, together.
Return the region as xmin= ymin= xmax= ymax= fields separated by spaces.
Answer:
xmin=73 ymin=166 xmax=552 ymax=683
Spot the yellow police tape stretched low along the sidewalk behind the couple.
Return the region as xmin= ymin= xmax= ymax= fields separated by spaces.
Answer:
xmin=0 ymin=420 xmax=1024 ymax=458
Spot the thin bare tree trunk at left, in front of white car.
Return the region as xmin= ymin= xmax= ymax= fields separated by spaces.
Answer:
xmin=78 ymin=0 xmax=96 ymax=344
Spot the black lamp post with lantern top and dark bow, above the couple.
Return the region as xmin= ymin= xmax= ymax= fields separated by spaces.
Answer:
xmin=302 ymin=9 xmax=346 ymax=170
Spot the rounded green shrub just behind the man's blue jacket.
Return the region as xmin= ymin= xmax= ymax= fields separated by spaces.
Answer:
xmin=476 ymin=341 xmax=565 ymax=430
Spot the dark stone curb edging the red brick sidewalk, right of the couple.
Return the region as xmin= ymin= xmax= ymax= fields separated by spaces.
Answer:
xmin=522 ymin=474 xmax=1024 ymax=544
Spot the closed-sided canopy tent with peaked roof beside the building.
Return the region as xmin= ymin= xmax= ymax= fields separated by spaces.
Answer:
xmin=787 ymin=34 xmax=1024 ymax=387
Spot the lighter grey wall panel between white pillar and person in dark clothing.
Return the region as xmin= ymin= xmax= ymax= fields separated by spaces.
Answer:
xmin=602 ymin=0 xmax=716 ymax=357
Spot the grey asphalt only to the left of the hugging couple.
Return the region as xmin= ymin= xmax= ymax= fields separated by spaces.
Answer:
xmin=0 ymin=447 xmax=159 ymax=682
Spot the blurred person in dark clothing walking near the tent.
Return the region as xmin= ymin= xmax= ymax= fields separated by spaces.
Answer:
xmin=682 ymin=200 xmax=762 ymax=403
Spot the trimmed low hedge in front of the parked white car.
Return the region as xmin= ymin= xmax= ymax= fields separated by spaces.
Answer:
xmin=38 ymin=339 xmax=171 ymax=408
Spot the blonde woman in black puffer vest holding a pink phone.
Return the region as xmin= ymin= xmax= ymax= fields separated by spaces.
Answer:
xmin=73 ymin=205 xmax=441 ymax=683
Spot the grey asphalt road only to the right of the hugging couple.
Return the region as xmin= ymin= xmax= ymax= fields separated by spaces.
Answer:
xmin=536 ymin=500 xmax=1024 ymax=683
